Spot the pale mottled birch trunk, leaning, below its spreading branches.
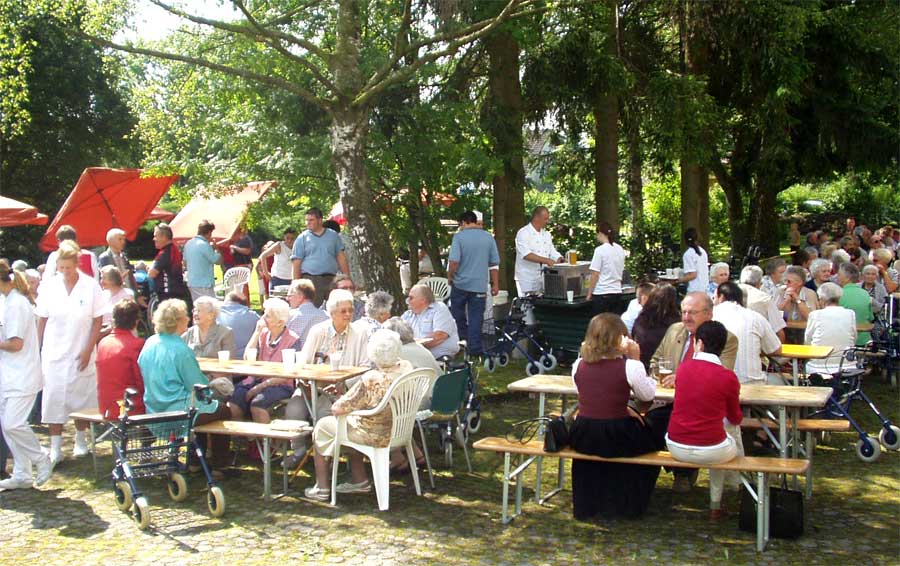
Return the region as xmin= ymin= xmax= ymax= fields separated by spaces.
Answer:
xmin=331 ymin=109 xmax=403 ymax=308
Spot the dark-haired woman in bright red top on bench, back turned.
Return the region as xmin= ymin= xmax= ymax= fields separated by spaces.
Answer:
xmin=666 ymin=321 xmax=743 ymax=520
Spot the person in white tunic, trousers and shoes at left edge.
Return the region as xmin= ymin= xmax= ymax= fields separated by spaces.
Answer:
xmin=0 ymin=260 xmax=53 ymax=489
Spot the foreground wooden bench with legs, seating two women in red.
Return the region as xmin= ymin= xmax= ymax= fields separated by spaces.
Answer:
xmin=473 ymin=437 xmax=809 ymax=552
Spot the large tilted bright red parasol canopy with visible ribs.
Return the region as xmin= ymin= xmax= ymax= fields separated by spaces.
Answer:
xmin=40 ymin=167 xmax=178 ymax=251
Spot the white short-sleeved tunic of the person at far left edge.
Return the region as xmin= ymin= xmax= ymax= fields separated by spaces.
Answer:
xmin=0 ymin=289 xmax=43 ymax=397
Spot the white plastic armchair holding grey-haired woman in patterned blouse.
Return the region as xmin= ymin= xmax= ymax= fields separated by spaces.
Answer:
xmin=331 ymin=368 xmax=435 ymax=511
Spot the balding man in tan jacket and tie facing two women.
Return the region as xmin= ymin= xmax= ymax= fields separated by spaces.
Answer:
xmin=644 ymin=291 xmax=738 ymax=493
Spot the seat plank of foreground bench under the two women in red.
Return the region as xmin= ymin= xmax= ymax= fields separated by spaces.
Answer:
xmin=473 ymin=436 xmax=809 ymax=474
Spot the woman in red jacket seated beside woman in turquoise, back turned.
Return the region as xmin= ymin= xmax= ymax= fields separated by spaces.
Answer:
xmin=97 ymin=302 xmax=145 ymax=420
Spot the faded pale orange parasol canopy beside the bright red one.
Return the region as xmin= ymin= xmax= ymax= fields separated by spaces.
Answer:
xmin=169 ymin=181 xmax=277 ymax=245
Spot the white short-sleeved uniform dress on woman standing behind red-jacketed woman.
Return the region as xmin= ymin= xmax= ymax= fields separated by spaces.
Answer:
xmin=35 ymin=272 xmax=106 ymax=424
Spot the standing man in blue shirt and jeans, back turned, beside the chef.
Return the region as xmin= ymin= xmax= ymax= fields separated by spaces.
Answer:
xmin=447 ymin=211 xmax=500 ymax=356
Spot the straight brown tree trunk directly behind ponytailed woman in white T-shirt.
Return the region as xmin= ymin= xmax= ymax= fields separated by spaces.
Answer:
xmin=593 ymin=0 xmax=619 ymax=230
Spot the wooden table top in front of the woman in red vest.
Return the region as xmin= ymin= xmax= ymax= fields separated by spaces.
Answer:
xmin=507 ymin=375 xmax=832 ymax=407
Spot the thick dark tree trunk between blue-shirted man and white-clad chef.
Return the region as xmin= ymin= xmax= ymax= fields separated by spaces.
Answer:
xmin=483 ymin=29 xmax=525 ymax=296
